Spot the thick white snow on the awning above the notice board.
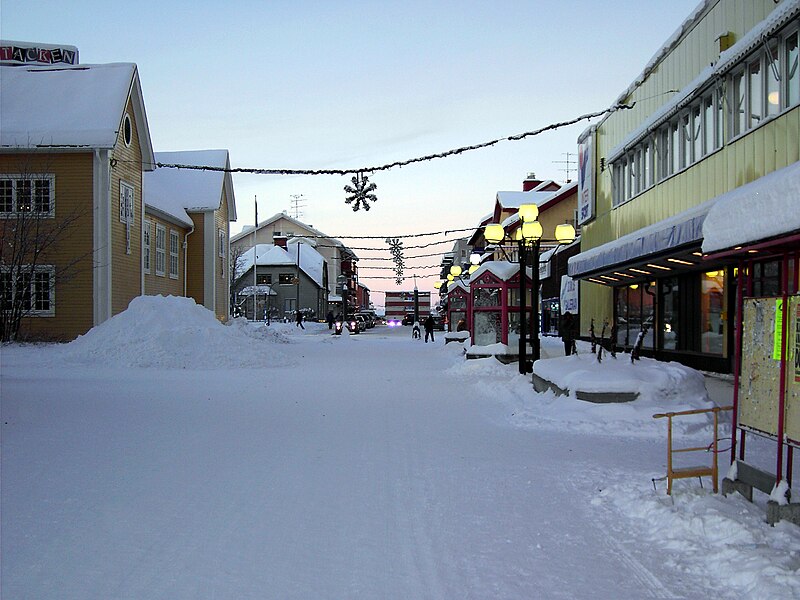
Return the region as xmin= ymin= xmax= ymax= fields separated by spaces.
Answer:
xmin=703 ymin=162 xmax=800 ymax=254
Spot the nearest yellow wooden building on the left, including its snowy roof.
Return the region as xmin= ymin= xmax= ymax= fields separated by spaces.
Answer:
xmin=0 ymin=63 xmax=154 ymax=340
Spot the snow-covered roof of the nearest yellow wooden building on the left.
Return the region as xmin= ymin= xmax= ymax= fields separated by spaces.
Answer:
xmin=0 ymin=63 xmax=153 ymax=165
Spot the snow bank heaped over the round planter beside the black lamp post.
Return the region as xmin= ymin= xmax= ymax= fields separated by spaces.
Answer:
xmin=448 ymin=338 xmax=716 ymax=442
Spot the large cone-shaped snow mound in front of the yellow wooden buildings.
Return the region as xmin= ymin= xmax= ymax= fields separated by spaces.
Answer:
xmin=60 ymin=296 xmax=293 ymax=369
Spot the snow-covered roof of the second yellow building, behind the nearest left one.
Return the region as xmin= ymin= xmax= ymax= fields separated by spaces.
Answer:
xmin=144 ymin=150 xmax=236 ymax=223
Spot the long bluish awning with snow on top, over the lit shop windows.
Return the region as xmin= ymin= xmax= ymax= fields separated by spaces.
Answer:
xmin=569 ymin=198 xmax=717 ymax=277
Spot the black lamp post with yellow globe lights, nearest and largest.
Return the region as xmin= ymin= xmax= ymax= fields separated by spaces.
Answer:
xmin=483 ymin=204 xmax=575 ymax=375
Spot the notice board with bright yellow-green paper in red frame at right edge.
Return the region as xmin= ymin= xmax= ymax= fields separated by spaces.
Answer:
xmin=738 ymin=296 xmax=800 ymax=445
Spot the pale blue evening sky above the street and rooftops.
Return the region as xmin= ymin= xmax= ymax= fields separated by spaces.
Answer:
xmin=0 ymin=0 xmax=699 ymax=304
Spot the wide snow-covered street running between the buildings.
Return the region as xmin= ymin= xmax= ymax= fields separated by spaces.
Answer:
xmin=0 ymin=298 xmax=800 ymax=600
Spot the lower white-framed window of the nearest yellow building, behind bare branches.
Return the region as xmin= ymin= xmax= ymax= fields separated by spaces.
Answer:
xmin=0 ymin=266 xmax=55 ymax=316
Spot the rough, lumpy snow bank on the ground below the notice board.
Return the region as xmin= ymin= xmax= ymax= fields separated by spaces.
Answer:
xmin=591 ymin=480 xmax=800 ymax=600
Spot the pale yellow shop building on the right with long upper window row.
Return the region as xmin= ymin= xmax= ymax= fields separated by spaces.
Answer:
xmin=569 ymin=0 xmax=800 ymax=371
